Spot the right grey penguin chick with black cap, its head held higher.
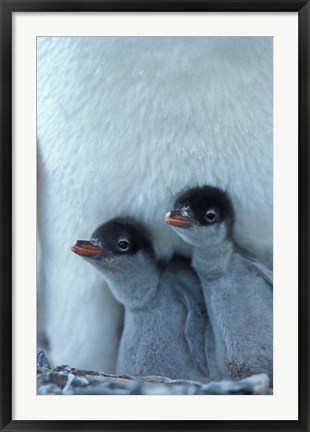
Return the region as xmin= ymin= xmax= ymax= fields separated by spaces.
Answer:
xmin=165 ymin=186 xmax=273 ymax=378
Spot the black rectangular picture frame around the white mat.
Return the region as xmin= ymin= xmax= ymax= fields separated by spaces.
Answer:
xmin=0 ymin=0 xmax=310 ymax=432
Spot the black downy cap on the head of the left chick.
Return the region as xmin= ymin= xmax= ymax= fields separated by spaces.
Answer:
xmin=92 ymin=217 xmax=154 ymax=255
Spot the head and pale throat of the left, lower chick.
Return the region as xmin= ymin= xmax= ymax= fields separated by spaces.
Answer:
xmin=71 ymin=217 xmax=157 ymax=305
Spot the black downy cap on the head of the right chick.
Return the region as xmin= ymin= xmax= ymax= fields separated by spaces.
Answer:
xmin=174 ymin=186 xmax=234 ymax=235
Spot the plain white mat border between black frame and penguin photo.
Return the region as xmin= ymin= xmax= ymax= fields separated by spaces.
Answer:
xmin=13 ymin=13 xmax=298 ymax=420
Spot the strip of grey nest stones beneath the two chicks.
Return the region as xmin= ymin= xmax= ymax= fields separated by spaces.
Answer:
xmin=37 ymin=351 xmax=272 ymax=395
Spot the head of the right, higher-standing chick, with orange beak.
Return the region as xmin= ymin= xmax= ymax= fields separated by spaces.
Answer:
xmin=165 ymin=186 xmax=234 ymax=247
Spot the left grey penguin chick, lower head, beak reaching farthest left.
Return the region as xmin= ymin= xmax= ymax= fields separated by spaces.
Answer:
xmin=71 ymin=218 xmax=208 ymax=381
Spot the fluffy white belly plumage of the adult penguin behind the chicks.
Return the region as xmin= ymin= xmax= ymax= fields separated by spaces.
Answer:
xmin=38 ymin=37 xmax=273 ymax=372
